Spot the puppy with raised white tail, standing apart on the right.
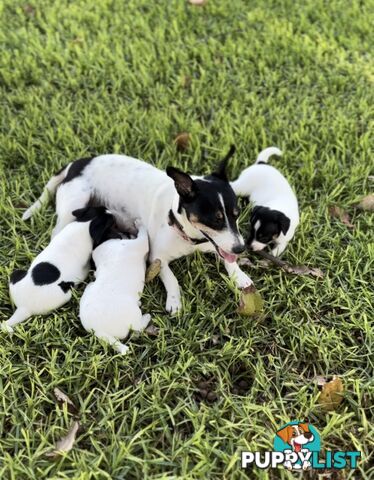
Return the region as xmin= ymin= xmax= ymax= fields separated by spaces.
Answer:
xmin=231 ymin=147 xmax=299 ymax=256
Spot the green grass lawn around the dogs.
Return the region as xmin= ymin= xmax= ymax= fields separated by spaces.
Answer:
xmin=0 ymin=0 xmax=374 ymax=480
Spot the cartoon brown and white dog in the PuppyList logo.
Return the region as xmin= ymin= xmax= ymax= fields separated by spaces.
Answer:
xmin=276 ymin=421 xmax=314 ymax=470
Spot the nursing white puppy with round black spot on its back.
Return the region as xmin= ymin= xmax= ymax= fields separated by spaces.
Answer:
xmin=3 ymin=207 xmax=114 ymax=331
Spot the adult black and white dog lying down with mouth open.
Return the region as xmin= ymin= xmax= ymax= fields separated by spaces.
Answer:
xmin=23 ymin=149 xmax=252 ymax=312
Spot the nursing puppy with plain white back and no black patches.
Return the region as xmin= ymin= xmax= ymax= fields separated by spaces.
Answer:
xmin=79 ymin=223 xmax=151 ymax=353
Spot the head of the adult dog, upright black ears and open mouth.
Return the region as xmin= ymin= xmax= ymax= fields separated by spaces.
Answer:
xmin=166 ymin=146 xmax=245 ymax=262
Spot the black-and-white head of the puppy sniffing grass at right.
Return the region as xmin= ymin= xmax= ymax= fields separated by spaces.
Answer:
xmin=247 ymin=206 xmax=290 ymax=251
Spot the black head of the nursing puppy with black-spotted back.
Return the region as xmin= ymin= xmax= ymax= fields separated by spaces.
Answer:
xmin=72 ymin=207 xmax=115 ymax=248
